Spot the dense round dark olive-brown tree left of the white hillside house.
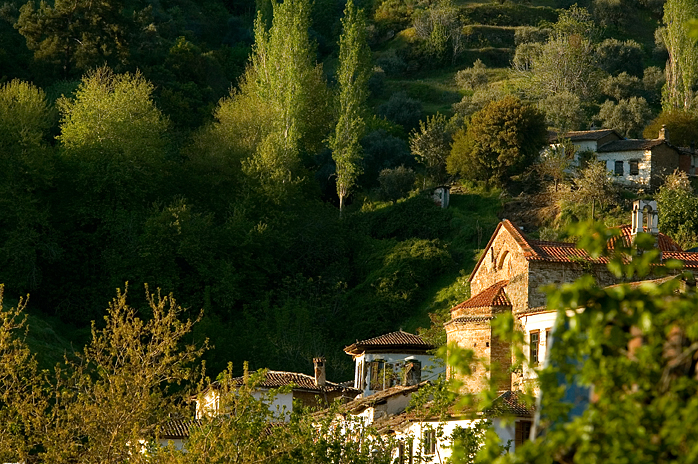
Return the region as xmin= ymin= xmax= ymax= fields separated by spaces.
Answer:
xmin=447 ymin=96 xmax=548 ymax=185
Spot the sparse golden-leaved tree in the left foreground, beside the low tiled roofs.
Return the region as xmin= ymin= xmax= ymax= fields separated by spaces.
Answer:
xmin=40 ymin=287 xmax=203 ymax=463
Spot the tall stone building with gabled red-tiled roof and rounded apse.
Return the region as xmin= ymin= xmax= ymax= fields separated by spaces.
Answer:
xmin=445 ymin=205 xmax=698 ymax=392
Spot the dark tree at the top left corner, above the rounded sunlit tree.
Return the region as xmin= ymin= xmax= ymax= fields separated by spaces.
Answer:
xmin=15 ymin=0 xmax=129 ymax=78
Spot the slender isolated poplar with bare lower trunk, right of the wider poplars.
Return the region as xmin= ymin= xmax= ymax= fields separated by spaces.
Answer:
xmin=330 ymin=0 xmax=371 ymax=215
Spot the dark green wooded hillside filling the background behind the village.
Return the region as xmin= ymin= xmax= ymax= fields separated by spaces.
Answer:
xmin=0 ymin=0 xmax=690 ymax=380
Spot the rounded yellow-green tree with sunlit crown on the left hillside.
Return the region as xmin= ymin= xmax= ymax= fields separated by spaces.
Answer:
xmin=57 ymin=68 xmax=168 ymax=209
